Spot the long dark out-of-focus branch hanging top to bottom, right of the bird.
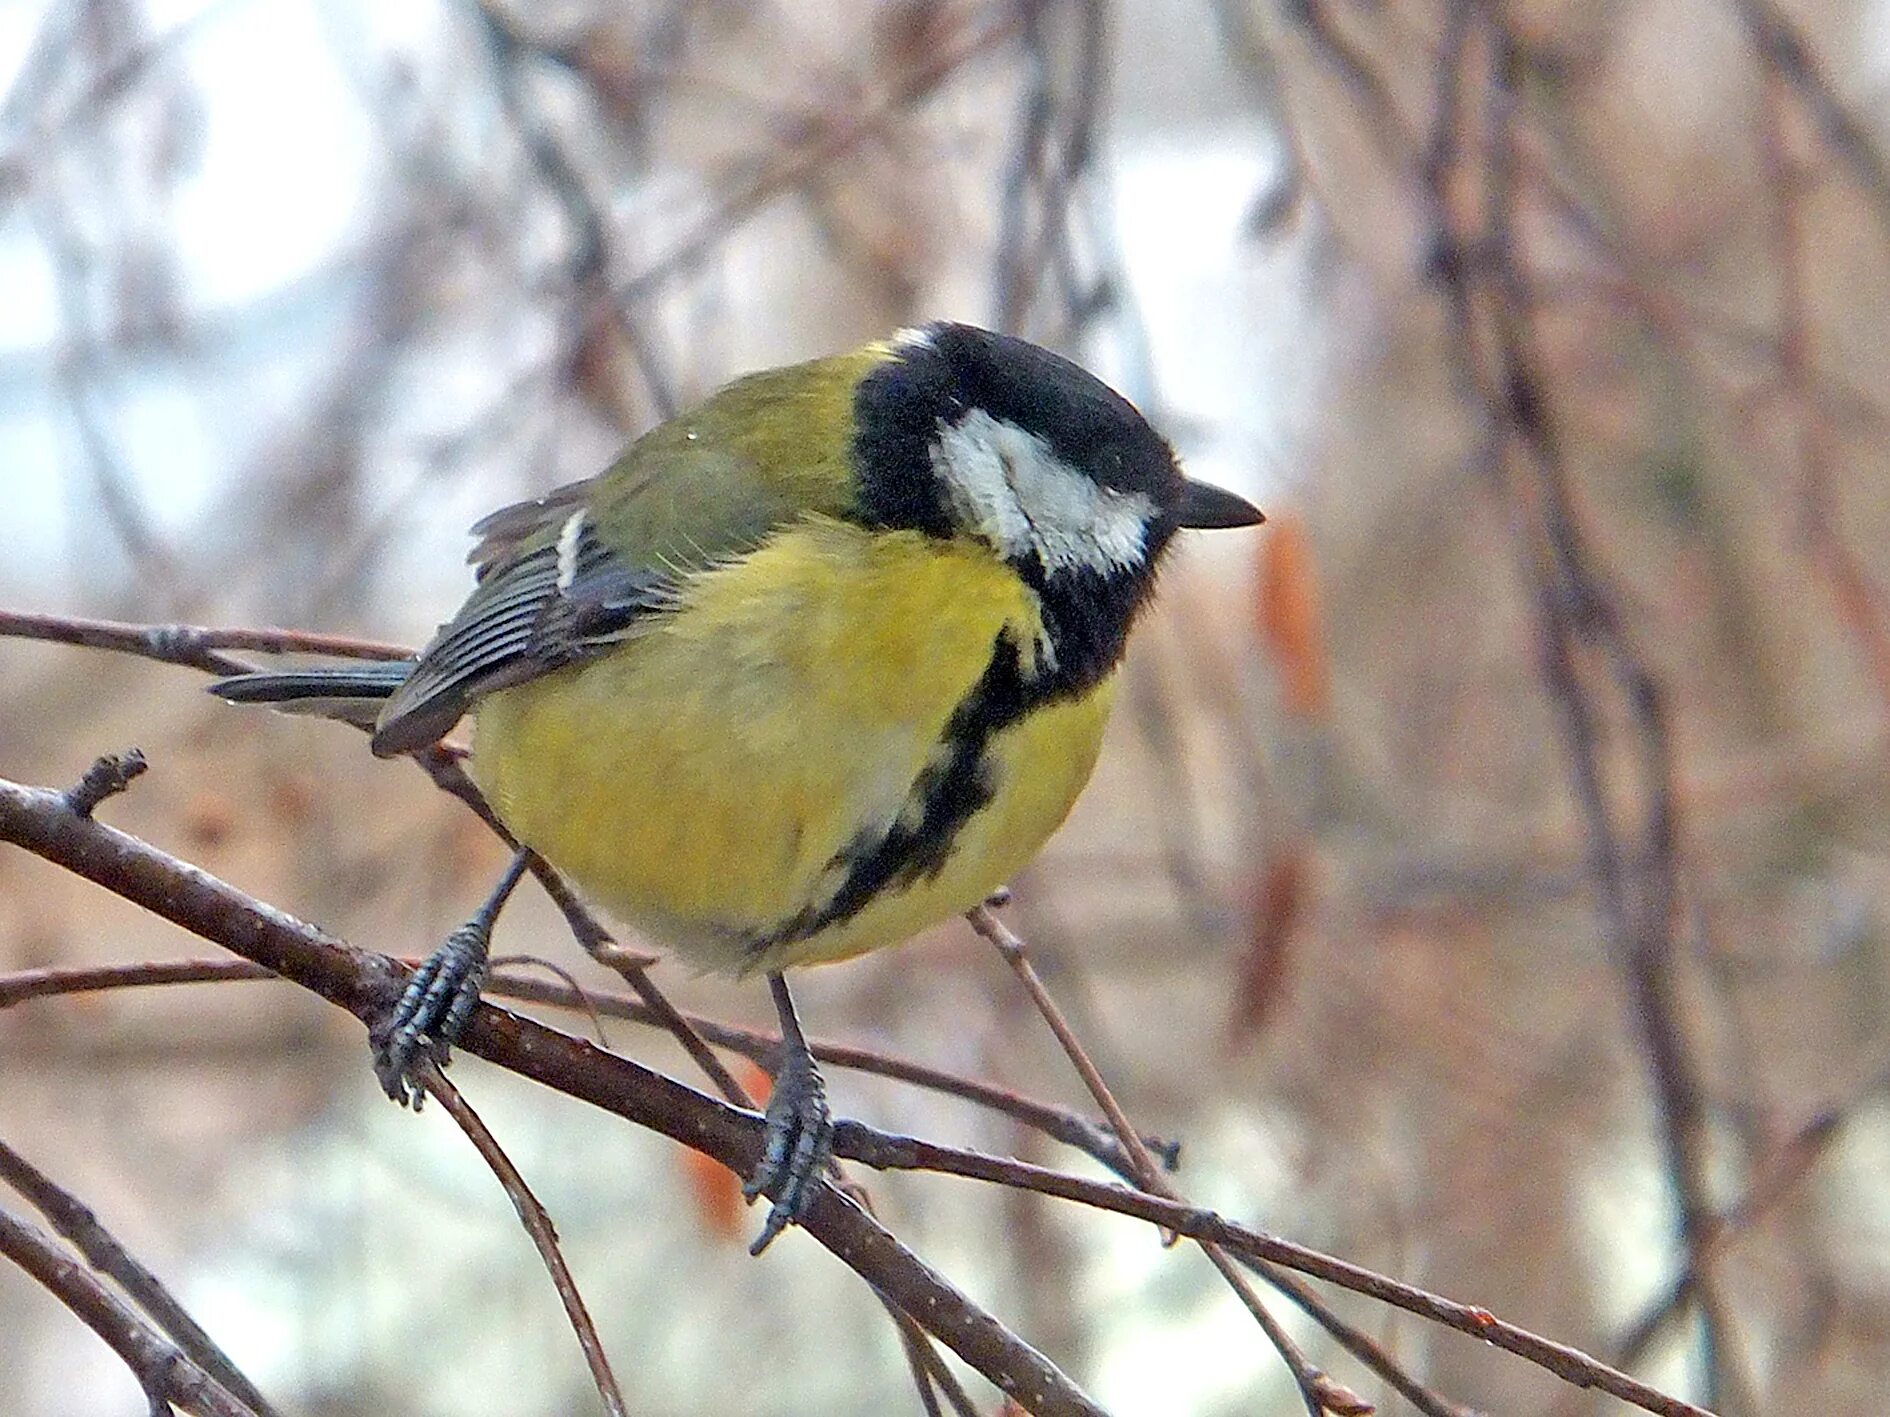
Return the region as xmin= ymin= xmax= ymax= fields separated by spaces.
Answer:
xmin=1425 ymin=0 xmax=1756 ymax=1413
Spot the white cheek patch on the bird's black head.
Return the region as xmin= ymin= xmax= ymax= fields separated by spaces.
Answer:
xmin=932 ymin=408 xmax=1155 ymax=574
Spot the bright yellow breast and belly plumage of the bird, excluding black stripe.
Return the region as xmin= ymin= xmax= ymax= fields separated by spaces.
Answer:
xmin=473 ymin=520 xmax=1111 ymax=973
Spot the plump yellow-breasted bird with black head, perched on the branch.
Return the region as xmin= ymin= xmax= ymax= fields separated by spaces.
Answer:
xmin=212 ymin=323 xmax=1261 ymax=1251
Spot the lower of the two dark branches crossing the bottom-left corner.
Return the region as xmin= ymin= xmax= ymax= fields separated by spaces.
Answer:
xmin=0 ymin=1209 xmax=261 ymax=1417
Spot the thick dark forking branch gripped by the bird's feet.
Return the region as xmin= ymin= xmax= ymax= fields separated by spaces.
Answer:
xmin=0 ymin=780 xmax=1707 ymax=1417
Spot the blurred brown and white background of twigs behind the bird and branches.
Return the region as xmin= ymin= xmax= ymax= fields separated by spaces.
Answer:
xmin=0 ymin=0 xmax=1890 ymax=1417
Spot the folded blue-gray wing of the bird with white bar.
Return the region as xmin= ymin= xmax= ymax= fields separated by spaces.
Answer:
xmin=372 ymin=506 xmax=679 ymax=756
